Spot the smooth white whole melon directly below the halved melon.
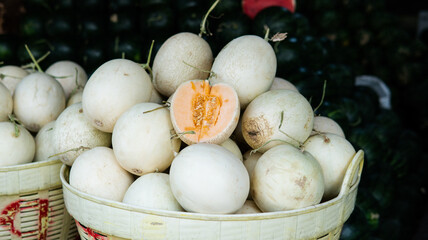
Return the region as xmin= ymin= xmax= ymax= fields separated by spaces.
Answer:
xmin=169 ymin=143 xmax=250 ymax=214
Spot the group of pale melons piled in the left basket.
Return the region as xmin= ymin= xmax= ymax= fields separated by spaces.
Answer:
xmin=0 ymin=58 xmax=88 ymax=167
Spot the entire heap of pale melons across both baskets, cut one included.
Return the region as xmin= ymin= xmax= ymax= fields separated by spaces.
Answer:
xmin=0 ymin=29 xmax=355 ymax=214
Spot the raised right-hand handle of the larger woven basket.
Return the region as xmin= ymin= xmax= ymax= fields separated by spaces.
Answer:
xmin=339 ymin=150 xmax=364 ymax=196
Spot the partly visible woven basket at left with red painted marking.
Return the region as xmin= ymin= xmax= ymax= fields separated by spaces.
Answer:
xmin=0 ymin=160 xmax=78 ymax=240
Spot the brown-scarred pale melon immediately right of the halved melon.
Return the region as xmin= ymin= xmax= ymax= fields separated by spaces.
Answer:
xmin=242 ymin=89 xmax=314 ymax=153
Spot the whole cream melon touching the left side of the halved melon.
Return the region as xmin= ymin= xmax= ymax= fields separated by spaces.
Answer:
xmin=112 ymin=102 xmax=181 ymax=176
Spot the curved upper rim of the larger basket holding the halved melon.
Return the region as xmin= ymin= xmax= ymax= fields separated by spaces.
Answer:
xmin=60 ymin=150 xmax=363 ymax=221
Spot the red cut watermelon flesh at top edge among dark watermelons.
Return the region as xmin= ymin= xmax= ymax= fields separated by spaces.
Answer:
xmin=242 ymin=0 xmax=296 ymax=18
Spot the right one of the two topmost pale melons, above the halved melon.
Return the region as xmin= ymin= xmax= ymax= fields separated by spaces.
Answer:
xmin=210 ymin=35 xmax=277 ymax=109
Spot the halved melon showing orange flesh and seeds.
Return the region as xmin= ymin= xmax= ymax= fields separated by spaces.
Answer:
xmin=170 ymin=80 xmax=240 ymax=145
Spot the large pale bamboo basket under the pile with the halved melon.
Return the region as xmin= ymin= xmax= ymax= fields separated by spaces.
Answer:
xmin=60 ymin=150 xmax=364 ymax=240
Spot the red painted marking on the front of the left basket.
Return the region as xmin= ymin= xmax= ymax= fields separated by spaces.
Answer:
xmin=0 ymin=199 xmax=49 ymax=239
